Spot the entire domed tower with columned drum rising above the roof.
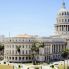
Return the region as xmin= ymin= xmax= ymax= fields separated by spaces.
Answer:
xmin=55 ymin=2 xmax=69 ymax=35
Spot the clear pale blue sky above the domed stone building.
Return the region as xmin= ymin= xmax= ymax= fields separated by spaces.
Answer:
xmin=0 ymin=0 xmax=69 ymax=36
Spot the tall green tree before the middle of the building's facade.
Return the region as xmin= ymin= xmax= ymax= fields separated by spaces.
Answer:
xmin=31 ymin=41 xmax=44 ymax=65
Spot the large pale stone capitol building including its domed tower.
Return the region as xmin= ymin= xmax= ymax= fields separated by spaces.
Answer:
xmin=4 ymin=2 xmax=69 ymax=62
